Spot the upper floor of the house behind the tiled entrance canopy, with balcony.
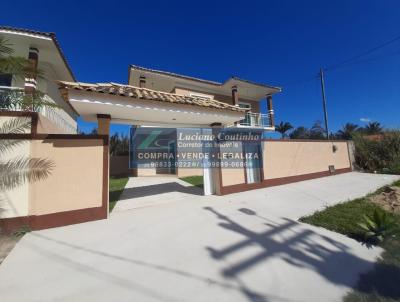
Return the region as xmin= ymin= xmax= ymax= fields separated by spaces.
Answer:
xmin=128 ymin=65 xmax=281 ymax=131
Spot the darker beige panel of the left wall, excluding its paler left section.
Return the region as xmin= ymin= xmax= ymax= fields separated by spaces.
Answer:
xmin=29 ymin=139 xmax=103 ymax=215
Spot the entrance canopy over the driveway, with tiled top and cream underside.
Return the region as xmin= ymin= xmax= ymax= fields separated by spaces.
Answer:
xmin=59 ymin=82 xmax=246 ymax=201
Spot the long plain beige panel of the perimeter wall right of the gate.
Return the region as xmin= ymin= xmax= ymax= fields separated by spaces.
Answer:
xmin=263 ymin=140 xmax=350 ymax=179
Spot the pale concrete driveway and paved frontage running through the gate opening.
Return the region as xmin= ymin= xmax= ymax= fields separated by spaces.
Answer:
xmin=0 ymin=173 xmax=397 ymax=302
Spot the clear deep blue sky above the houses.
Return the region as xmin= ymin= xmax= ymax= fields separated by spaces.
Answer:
xmin=0 ymin=0 xmax=400 ymax=133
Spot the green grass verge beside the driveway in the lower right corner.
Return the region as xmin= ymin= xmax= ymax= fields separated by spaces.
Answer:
xmin=300 ymin=181 xmax=400 ymax=302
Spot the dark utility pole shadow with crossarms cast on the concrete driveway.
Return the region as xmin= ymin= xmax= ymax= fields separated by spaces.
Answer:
xmin=204 ymin=207 xmax=400 ymax=302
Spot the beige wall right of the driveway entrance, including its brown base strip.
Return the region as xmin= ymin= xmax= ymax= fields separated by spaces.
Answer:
xmin=220 ymin=140 xmax=351 ymax=194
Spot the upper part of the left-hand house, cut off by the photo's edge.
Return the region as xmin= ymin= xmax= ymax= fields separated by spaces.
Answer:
xmin=0 ymin=26 xmax=78 ymax=134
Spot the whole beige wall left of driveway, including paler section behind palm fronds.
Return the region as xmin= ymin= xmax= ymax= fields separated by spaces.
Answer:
xmin=0 ymin=138 xmax=107 ymax=218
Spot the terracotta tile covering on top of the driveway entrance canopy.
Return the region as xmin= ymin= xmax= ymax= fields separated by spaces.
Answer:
xmin=58 ymin=81 xmax=246 ymax=112
